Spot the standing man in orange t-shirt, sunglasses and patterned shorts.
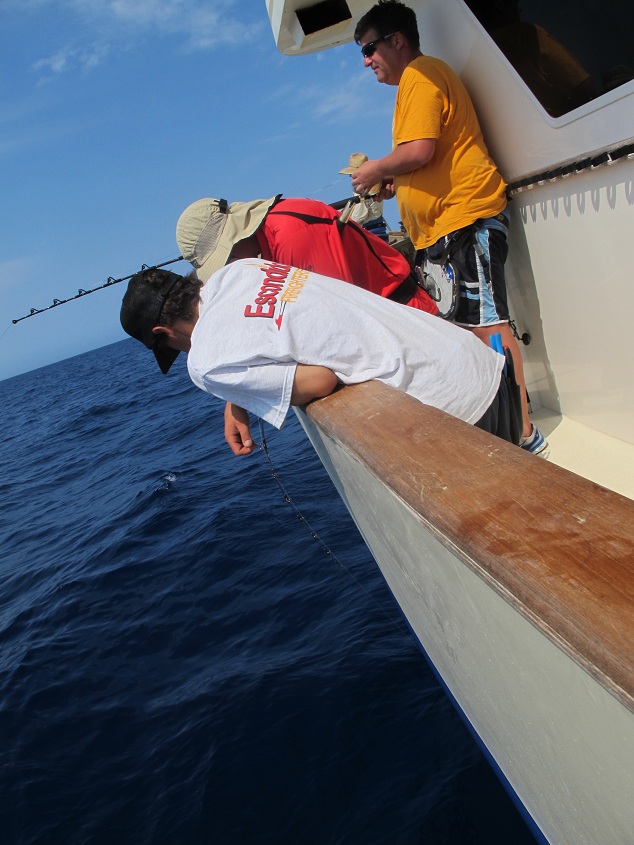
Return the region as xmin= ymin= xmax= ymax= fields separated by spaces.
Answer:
xmin=352 ymin=0 xmax=548 ymax=454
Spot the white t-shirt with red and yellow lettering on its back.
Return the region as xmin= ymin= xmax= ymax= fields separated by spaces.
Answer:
xmin=187 ymin=258 xmax=504 ymax=428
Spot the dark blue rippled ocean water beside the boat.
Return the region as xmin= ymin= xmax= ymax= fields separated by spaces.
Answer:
xmin=0 ymin=340 xmax=534 ymax=845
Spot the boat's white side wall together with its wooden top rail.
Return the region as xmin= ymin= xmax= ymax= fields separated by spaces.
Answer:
xmin=299 ymin=382 xmax=634 ymax=845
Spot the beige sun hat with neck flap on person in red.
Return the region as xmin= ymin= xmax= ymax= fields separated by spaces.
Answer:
xmin=176 ymin=194 xmax=281 ymax=283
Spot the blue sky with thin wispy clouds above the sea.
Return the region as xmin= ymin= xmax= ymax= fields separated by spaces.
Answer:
xmin=0 ymin=0 xmax=398 ymax=379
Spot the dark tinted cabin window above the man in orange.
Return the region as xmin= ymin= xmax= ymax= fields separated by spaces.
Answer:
xmin=465 ymin=0 xmax=634 ymax=117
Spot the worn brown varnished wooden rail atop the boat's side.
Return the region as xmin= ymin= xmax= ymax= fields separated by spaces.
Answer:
xmin=306 ymin=382 xmax=634 ymax=710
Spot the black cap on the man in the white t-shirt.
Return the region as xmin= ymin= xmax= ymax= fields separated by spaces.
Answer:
xmin=121 ymin=268 xmax=183 ymax=374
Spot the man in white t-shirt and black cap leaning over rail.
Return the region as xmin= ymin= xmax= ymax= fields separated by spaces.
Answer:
xmin=121 ymin=258 xmax=510 ymax=439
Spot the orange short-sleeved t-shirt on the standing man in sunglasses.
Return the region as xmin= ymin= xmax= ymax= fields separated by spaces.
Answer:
xmin=392 ymin=56 xmax=506 ymax=249
